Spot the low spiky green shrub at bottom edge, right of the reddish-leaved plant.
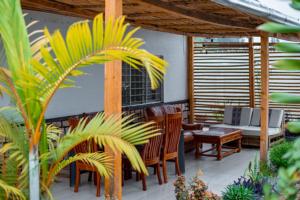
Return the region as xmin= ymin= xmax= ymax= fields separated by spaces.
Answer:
xmin=222 ymin=184 xmax=255 ymax=200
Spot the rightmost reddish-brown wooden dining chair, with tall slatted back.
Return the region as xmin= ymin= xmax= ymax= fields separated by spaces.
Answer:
xmin=161 ymin=112 xmax=182 ymax=183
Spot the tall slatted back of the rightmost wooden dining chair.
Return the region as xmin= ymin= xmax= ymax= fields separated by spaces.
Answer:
xmin=164 ymin=112 xmax=182 ymax=154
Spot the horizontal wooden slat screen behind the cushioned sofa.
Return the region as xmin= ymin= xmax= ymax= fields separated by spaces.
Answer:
xmin=194 ymin=42 xmax=300 ymax=123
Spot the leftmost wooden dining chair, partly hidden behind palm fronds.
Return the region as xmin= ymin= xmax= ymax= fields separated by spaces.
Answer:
xmin=68 ymin=118 xmax=101 ymax=197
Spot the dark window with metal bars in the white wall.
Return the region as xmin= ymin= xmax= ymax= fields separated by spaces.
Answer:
xmin=122 ymin=56 xmax=163 ymax=106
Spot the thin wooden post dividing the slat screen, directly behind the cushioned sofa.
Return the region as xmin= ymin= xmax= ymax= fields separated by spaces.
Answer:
xmin=249 ymin=37 xmax=255 ymax=108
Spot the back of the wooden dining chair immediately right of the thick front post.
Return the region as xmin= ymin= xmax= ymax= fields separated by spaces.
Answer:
xmin=142 ymin=116 xmax=164 ymax=162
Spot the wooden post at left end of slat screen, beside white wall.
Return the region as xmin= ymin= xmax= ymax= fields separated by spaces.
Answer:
xmin=187 ymin=36 xmax=195 ymax=123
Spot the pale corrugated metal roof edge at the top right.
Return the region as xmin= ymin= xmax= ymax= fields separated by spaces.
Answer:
xmin=213 ymin=0 xmax=300 ymax=25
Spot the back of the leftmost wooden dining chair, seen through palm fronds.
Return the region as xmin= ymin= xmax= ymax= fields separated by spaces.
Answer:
xmin=68 ymin=118 xmax=98 ymax=154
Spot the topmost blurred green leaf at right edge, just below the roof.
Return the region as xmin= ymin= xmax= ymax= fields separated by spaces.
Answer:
xmin=258 ymin=22 xmax=300 ymax=33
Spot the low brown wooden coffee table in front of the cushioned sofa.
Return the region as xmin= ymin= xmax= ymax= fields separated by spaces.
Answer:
xmin=192 ymin=128 xmax=242 ymax=160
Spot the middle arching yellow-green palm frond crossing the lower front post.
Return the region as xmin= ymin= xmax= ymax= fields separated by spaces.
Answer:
xmin=50 ymin=113 xmax=157 ymax=174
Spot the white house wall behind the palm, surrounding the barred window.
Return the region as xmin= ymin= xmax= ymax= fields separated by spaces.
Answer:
xmin=0 ymin=11 xmax=187 ymax=118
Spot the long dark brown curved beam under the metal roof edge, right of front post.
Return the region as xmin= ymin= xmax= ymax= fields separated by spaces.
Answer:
xmin=140 ymin=0 xmax=257 ymax=29
